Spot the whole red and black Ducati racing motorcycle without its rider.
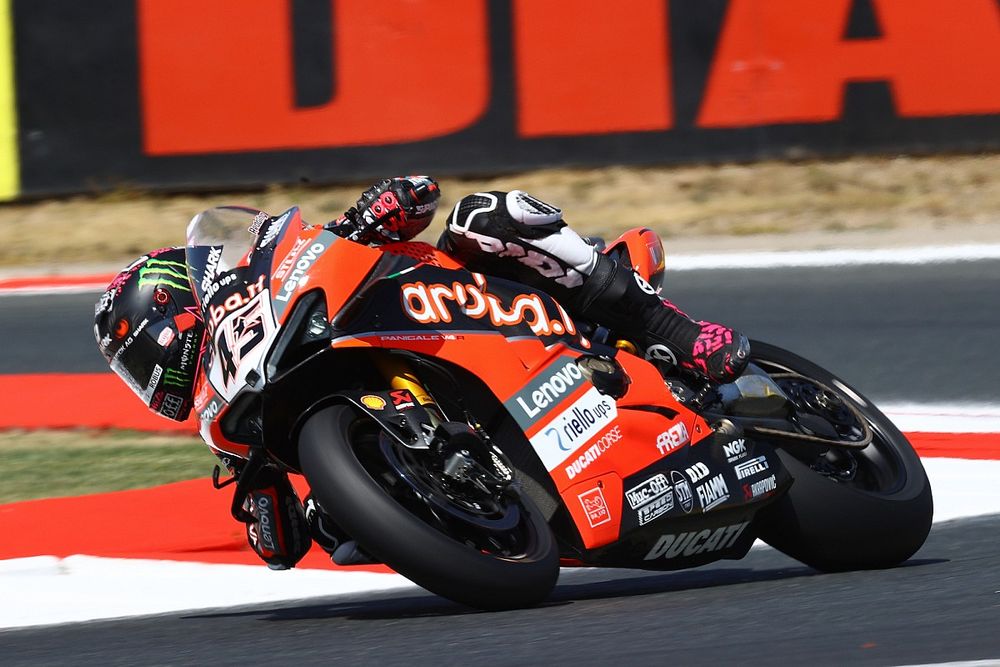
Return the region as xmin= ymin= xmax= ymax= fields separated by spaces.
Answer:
xmin=187 ymin=207 xmax=932 ymax=609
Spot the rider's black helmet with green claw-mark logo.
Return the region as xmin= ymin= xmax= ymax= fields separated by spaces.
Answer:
xmin=94 ymin=248 xmax=205 ymax=421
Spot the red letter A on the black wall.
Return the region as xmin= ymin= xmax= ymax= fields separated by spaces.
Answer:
xmin=698 ymin=0 xmax=1000 ymax=127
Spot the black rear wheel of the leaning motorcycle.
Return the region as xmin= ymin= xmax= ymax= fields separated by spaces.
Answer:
xmin=751 ymin=342 xmax=933 ymax=571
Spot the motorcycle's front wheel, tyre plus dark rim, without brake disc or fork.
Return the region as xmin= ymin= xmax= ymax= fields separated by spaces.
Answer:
xmin=299 ymin=405 xmax=559 ymax=609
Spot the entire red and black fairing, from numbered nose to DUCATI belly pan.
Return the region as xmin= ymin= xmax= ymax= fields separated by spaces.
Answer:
xmin=188 ymin=211 xmax=787 ymax=569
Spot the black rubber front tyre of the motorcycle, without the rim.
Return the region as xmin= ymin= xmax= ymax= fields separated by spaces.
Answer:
xmin=299 ymin=405 xmax=559 ymax=609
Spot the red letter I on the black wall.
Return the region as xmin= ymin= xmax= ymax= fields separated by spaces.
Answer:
xmin=514 ymin=0 xmax=673 ymax=137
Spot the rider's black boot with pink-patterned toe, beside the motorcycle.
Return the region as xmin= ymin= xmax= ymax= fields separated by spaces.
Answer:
xmin=575 ymin=254 xmax=750 ymax=382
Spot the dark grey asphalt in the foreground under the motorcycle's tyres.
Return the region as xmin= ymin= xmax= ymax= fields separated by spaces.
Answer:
xmin=0 ymin=515 xmax=1000 ymax=667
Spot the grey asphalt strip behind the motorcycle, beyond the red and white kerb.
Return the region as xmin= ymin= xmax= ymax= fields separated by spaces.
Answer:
xmin=0 ymin=259 xmax=1000 ymax=403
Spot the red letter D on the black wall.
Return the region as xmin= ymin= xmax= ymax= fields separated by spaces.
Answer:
xmin=138 ymin=0 xmax=490 ymax=155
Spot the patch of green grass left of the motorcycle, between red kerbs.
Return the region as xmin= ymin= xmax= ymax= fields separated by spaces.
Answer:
xmin=0 ymin=430 xmax=217 ymax=503
